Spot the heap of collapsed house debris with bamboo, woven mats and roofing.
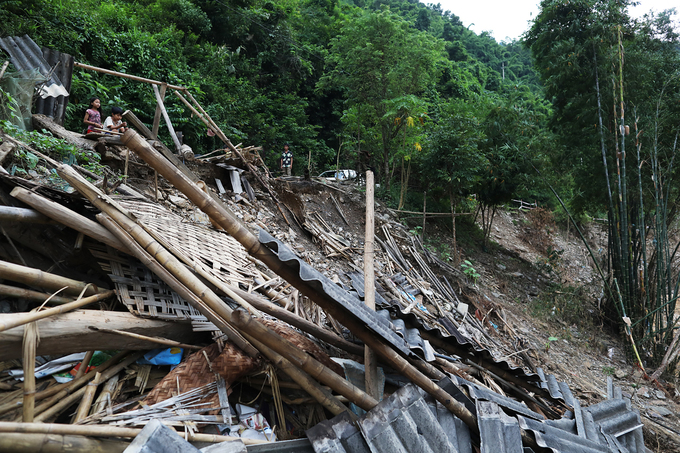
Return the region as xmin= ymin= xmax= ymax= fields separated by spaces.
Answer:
xmin=0 ymin=38 xmax=668 ymax=453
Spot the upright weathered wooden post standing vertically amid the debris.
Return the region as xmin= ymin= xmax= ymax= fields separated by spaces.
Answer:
xmin=364 ymin=170 xmax=382 ymax=401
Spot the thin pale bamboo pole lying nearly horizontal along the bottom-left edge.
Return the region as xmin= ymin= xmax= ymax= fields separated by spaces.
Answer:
xmin=0 ymin=422 xmax=265 ymax=445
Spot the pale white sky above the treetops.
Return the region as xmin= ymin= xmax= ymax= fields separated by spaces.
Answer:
xmin=430 ymin=0 xmax=680 ymax=42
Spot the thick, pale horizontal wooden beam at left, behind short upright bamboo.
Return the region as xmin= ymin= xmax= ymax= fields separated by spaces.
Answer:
xmin=0 ymin=310 xmax=194 ymax=360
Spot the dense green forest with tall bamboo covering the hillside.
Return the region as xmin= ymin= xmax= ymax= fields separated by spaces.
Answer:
xmin=0 ymin=0 xmax=680 ymax=361
